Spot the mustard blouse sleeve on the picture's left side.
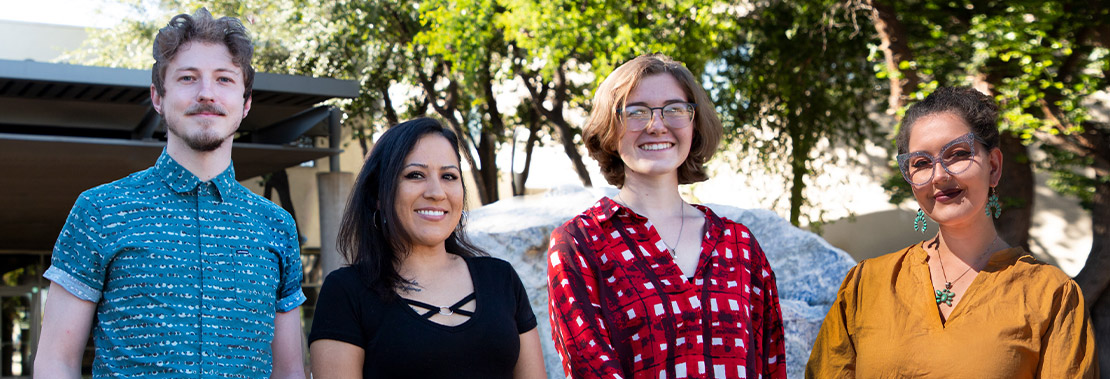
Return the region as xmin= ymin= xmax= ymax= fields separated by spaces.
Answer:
xmin=806 ymin=261 xmax=866 ymax=378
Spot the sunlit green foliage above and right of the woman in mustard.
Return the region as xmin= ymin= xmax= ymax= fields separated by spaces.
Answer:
xmin=877 ymin=0 xmax=1110 ymax=210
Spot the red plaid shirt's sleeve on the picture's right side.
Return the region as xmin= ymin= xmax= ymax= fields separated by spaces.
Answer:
xmin=751 ymin=237 xmax=786 ymax=379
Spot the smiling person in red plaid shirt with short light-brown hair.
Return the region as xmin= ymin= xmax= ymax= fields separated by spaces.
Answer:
xmin=547 ymin=54 xmax=786 ymax=379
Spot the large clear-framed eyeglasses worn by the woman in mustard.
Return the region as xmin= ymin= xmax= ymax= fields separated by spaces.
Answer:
xmin=898 ymin=133 xmax=982 ymax=187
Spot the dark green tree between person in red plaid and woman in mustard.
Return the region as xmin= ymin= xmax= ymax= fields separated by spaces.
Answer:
xmin=708 ymin=1 xmax=877 ymax=225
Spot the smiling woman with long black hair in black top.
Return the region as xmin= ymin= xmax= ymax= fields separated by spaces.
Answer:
xmin=309 ymin=119 xmax=546 ymax=379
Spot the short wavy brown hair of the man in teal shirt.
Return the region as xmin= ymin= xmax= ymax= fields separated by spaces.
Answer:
xmin=151 ymin=8 xmax=254 ymax=102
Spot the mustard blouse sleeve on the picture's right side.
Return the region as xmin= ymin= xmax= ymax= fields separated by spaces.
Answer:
xmin=1037 ymin=275 xmax=1099 ymax=378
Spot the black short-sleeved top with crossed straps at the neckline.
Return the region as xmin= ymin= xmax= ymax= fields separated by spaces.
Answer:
xmin=309 ymin=257 xmax=536 ymax=378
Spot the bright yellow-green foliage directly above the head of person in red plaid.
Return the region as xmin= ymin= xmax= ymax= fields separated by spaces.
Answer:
xmin=497 ymin=0 xmax=734 ymax=104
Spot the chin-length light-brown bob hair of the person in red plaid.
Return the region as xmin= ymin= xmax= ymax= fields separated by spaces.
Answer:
xmin=582 ymin=54 xmax=724 ymax=188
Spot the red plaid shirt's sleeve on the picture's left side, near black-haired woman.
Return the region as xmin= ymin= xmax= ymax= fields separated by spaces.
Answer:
xmin=547 ymin=220 xmax=624 ymax=378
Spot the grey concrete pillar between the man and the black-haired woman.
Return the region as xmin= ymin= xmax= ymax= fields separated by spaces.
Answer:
xmin=316 ymin=172 xmax=354 ymax=278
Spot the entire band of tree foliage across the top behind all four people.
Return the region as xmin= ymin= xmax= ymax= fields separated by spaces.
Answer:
xmin=67 ymin=0 xmax=1110 ymax=225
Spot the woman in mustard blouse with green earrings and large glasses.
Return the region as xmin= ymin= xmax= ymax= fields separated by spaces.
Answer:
xmin=806 ymin=88 xmax=1098 ymax=378
